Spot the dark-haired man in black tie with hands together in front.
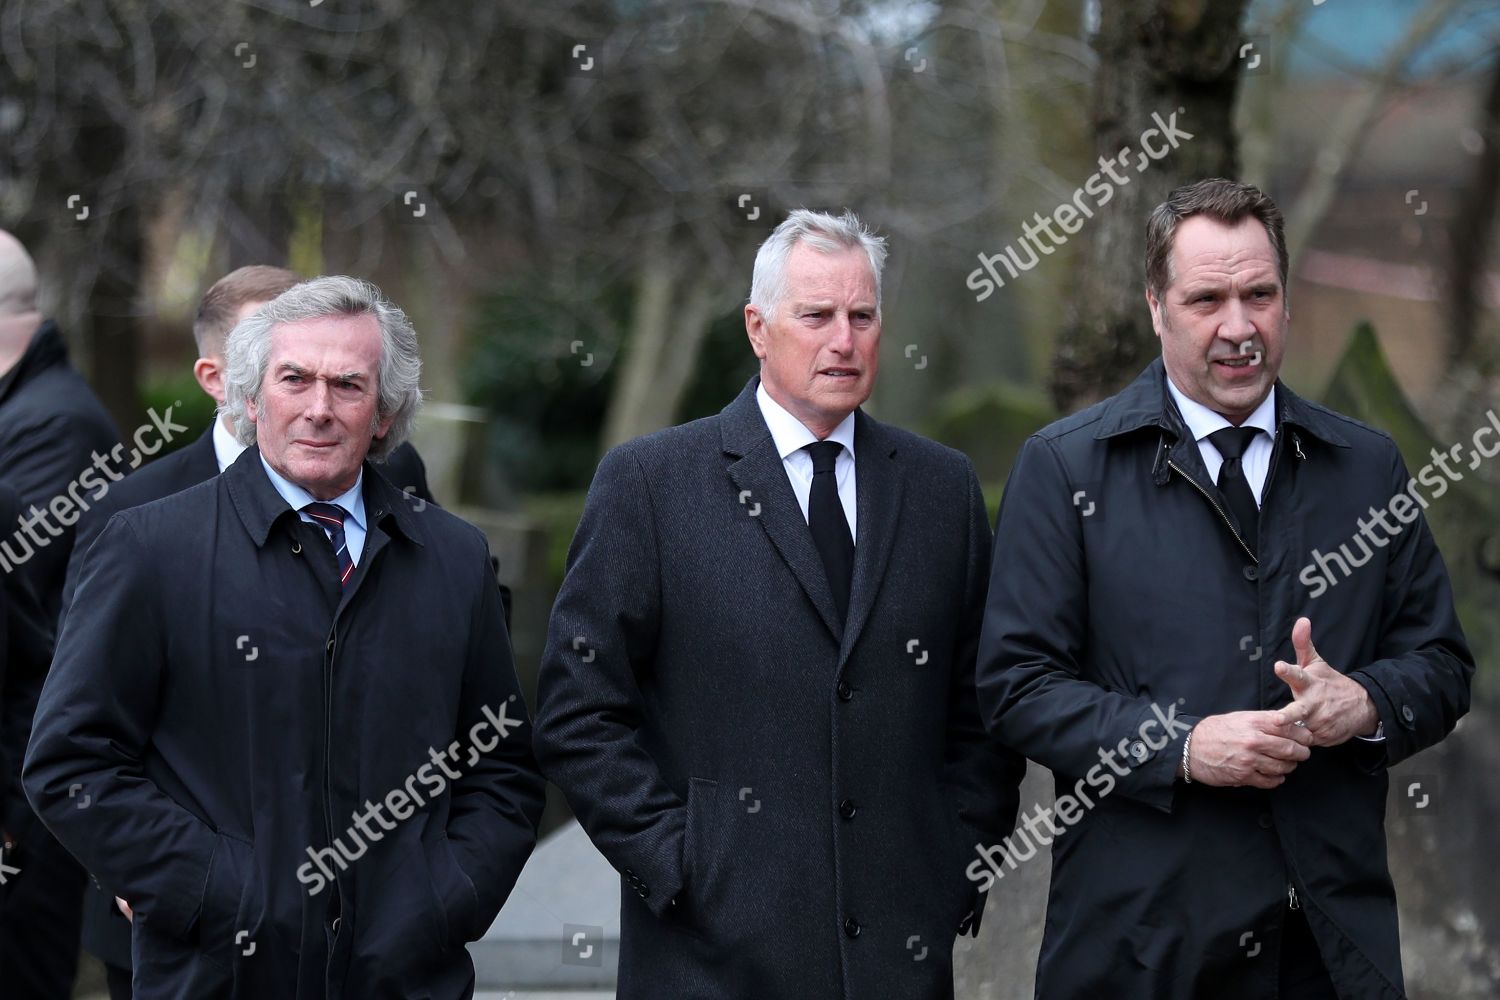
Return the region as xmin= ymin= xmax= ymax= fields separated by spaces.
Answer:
xmin=978 ymin=180 xmax=1475 ymax=1000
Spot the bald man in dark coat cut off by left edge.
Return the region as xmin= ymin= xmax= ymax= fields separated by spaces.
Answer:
xmin=0 ymin=231 xmax=125 ymax=1000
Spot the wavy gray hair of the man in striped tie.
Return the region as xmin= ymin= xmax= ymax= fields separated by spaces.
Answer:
xmin=224 ymin=274 xmax=422 ymax=462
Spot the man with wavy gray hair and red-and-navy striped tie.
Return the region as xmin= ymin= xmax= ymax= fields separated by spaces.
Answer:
xmin=24 ymin=277 xmax=543 ymax=1000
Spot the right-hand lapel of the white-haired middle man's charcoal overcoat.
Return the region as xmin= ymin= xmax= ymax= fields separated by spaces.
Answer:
xmin=840 ymin=411 xmax=903 ymax=670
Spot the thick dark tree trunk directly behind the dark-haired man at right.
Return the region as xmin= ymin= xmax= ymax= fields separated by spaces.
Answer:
xmin=1052 ymin=0 xmax=1248 ymax=412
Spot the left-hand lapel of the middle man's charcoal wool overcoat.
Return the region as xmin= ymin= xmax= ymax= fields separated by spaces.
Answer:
xmin=720 ymin=378 xmax=846 ymax=639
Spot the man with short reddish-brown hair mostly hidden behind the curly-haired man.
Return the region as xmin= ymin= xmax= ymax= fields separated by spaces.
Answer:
xmin=63 ymin=264 xmax=434 ymax=1000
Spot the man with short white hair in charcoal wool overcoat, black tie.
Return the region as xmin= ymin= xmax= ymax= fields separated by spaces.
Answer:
xmin=537 ymin=210 xmax=1025 ymax=1000
